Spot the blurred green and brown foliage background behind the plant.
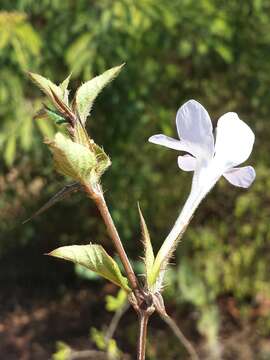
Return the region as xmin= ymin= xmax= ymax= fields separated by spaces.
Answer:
xmin=0 ymin=0 xmax=270 ymax=360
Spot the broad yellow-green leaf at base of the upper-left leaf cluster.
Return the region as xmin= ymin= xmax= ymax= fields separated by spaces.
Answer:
xmin=46 ymin=133 xmax=97 ymax=183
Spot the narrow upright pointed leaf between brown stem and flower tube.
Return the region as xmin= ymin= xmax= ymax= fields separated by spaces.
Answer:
xmin=138 ymin=204 xmax=155 ymax=286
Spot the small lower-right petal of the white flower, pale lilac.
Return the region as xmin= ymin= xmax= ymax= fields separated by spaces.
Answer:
xmin=223 ymin=166 xmax=256 ymax=188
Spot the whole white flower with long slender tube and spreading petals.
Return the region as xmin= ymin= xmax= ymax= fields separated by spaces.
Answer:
xmin=149 ymin=100 xmax=256 ymax=290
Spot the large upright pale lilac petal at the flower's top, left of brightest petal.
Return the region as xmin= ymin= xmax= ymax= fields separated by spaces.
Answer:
xmin=176 ymin=100 xmax=214 ymax=157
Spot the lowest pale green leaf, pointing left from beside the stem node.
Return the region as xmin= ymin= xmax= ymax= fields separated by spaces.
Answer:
xmin=48 ymin=244 xmax=131 ymax=292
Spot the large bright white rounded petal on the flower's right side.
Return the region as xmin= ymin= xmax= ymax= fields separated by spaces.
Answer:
xmin=215 ymin=112 xmax=255 ymax=169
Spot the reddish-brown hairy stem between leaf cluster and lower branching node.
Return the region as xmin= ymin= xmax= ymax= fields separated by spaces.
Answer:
xmin=85 ymin=185 xmax=139 ymax=296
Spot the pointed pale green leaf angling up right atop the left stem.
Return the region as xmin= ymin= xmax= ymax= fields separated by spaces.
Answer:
xmin=75 ymin=64 xmax=124 ymax=124
